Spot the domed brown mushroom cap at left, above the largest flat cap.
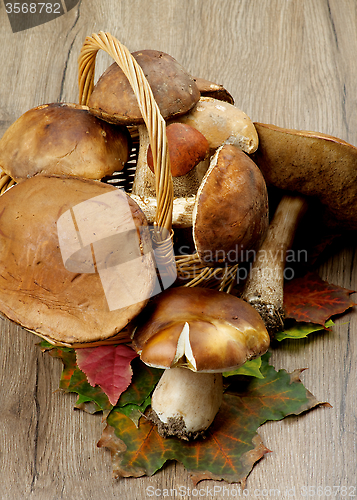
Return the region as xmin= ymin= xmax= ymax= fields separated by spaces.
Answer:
xmin=0 ymin=103 xmax=130 ymax=181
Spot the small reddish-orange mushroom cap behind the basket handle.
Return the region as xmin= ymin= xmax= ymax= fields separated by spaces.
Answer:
xmin=147 ymin=123 xmax=209 ymax=177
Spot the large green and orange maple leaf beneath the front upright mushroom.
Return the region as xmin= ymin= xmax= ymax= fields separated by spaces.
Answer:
xmin=98 ymin=354 xmax=321 ymax=483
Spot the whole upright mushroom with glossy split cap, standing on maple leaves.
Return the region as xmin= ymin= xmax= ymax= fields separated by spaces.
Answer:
xmin=133 ymin=287 xmax=269 ymax=439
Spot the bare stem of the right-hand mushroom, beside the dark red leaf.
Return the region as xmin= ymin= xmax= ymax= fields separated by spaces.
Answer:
xmin=242 ymin=195 xmax=308 ymax=336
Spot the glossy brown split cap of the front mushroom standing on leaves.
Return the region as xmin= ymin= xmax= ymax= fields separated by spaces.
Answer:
xmin=133 ymin=287 xmax=270 ymax=372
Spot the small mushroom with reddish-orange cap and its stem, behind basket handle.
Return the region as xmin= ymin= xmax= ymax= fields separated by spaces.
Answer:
xmin=146 ymin=123 xmax=209 ymax=198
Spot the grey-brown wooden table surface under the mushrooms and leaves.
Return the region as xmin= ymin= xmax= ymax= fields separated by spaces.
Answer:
xmin=0 ymin=0 xmax=357 ymax=500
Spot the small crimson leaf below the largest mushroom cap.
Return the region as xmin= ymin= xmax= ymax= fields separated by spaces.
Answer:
xmin=75 ymin=344 xmax=138 ymax=406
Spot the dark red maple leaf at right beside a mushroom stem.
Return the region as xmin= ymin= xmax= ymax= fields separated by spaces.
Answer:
xmin=284 ymin=272 xmax=356 ymax=325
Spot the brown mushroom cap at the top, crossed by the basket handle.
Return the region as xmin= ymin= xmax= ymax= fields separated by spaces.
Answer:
xmin=88 ymin=50 xmax=200 ymax=125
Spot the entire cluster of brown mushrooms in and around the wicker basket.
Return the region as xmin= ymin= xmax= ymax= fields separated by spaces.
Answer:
xmin=0 ymin=34 xmax=357 ymax=439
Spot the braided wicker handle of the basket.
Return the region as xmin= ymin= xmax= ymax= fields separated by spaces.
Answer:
xmin=78 ymin=31 xmax=173 ymax=234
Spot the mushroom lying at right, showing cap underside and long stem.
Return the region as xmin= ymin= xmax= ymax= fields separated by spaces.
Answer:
xmin=242 ymin=123 xmax=357 ymax=335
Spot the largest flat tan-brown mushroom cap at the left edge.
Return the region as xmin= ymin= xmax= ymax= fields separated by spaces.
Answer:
xmin=0 ymin=175 xmax=156 ymax=343
